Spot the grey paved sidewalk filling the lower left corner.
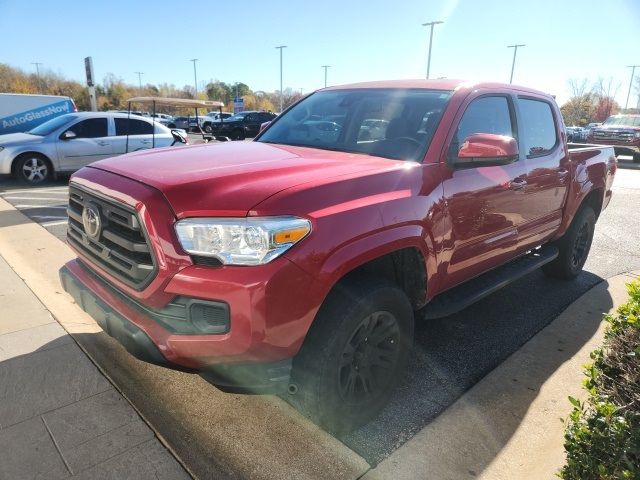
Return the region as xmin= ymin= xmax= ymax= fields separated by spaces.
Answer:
xmin=0 ymin=256 xmax=191 ymax=480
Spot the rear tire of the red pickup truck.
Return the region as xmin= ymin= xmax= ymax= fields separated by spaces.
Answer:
xmin=542 ymin=205 xmax=596 ymax=280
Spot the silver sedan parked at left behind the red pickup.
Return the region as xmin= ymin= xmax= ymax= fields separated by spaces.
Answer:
xmin=0 ymin=112 xmax=182 ymax=185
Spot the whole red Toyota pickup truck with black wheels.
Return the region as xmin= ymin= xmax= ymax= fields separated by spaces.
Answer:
xmin=60 ymin=80 xmax=617 ymax=430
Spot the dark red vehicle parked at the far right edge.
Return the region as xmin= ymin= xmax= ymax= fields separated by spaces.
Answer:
xmin=587 ymin=115 xmax=640 ymax=163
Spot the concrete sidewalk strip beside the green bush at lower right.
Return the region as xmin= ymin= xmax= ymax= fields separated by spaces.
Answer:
xmin=363 ymin=272 xmax=640 ymax=480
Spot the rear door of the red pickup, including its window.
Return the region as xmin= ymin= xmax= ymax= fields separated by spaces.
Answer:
xmin=517 ymin=96 xmax=570 ymax=250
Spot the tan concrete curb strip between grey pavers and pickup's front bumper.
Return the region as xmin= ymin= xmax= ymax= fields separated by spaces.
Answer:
xmin=0 ymin=198 xmax=370 ymax=480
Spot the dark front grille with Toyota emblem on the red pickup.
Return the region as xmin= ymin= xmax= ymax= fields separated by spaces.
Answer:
xmin=67 ymin=185 xmax=157 ymax=290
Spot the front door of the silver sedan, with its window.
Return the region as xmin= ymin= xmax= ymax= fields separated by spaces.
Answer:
xmin=57 ymin=117 xmax=113 ymax=171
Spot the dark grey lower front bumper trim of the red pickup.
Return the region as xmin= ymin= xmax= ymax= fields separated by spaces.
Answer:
xmin=59 ymin=260 xmax=292 ymax=394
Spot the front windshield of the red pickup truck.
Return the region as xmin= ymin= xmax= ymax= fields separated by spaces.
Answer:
xmin=258 ymin=89 xmax=452 ymax=161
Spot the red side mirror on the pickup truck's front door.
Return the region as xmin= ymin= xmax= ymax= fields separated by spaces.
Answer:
xmin=450 ymin=133 xmax=519 ymax=168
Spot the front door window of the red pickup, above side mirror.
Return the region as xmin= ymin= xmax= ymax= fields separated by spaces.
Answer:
xmin=450 ymin=97 xmax=514 ymax=155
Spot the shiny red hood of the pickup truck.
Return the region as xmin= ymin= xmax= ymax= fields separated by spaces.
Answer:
xmin=90 ymin=142 xmax=406 ymax=218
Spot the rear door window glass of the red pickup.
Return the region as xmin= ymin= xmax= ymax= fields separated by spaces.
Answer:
xmin=519 ymin=98 xmax=558 ymax=156
